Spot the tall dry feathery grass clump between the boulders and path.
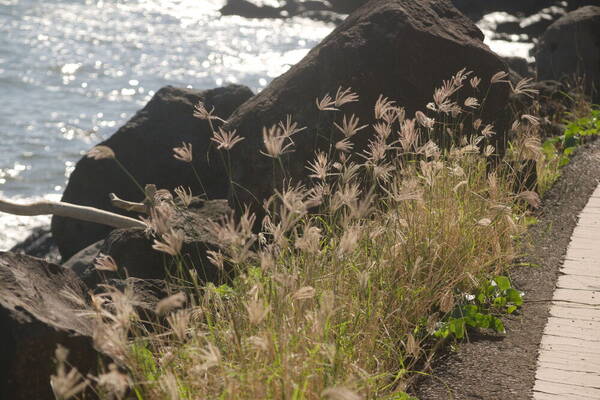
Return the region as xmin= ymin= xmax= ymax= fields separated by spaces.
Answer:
xmin=59 ymin=70 xmax=542 ymax=400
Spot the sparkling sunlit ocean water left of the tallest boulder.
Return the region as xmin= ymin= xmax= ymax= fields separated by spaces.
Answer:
xmin=0 ymin=0 xmax=334 ymax=250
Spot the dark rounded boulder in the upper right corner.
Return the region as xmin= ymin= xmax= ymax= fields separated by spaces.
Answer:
xmin=536 ymin=6 xmax=600 ymax=101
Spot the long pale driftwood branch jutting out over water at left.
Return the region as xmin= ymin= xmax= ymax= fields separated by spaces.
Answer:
xmin=0 ymin=199 xmax=146 ymax=228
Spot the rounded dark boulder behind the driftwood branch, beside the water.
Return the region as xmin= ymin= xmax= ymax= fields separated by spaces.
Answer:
xmin=52 ymin=85 xmax=252 ymax=260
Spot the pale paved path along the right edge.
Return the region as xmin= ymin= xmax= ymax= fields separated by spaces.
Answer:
xmin=533 ymin=185 xmax=600 ymax=400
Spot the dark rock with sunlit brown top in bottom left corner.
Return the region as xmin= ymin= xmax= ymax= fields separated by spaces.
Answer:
xmin=0 ymin=253 xmax=98 ymax=400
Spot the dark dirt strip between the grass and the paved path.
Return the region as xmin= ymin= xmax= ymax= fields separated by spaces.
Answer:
xmin=412 ymin=141 xmax=600 ymax=400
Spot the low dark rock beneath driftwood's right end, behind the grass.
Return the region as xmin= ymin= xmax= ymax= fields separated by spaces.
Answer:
xmin=64 ymin=200 xmax=232 ymax=288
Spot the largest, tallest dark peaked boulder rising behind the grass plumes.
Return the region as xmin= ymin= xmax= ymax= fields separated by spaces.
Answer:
xmin=225 ymin=0 xmax=509 ymax=209
